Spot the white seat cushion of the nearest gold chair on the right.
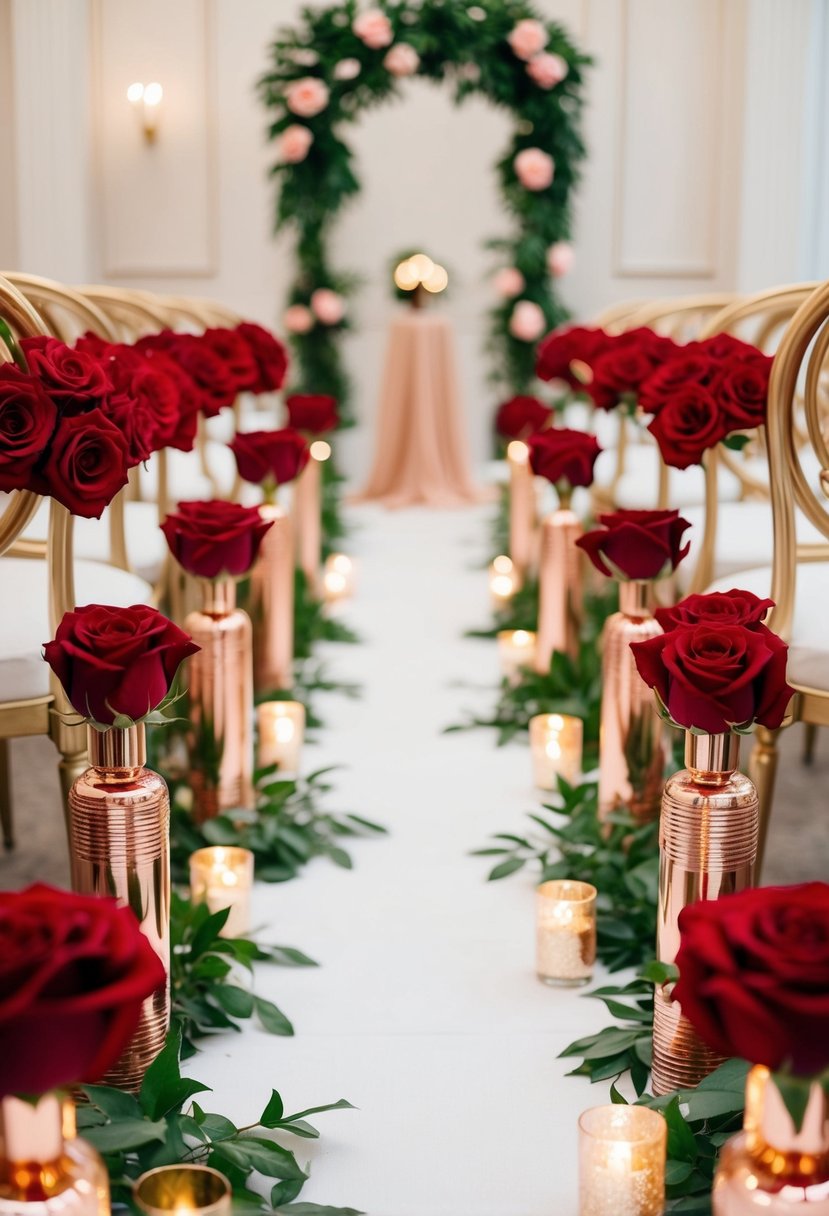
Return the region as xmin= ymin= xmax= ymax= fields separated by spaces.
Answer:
xmin=707 ymin=562 xmax=829 ymax=692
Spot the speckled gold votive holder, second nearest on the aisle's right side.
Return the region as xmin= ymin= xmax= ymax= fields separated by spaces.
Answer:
xmin=535 ymin=878 xmax=596 ymax=987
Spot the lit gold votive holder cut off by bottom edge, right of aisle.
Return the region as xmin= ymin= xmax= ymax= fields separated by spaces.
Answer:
xmin=579 ymin=1105 xmax=667 ymax=1216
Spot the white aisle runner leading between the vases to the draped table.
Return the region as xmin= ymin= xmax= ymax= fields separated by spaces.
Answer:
xmin=193 ymin=507 xmax=609 ymax=1216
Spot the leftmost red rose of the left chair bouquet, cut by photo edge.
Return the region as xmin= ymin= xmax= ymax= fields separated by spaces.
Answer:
xmin=0 ymin=364 xmax=57 ymax=490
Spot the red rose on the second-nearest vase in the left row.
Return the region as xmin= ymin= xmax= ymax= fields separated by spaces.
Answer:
xmin=44 ymin=604 xmax=198 ymax=726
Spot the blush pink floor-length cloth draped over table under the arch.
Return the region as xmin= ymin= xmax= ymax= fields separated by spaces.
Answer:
xmin=354 ymin=310 xmax=481 ymax=507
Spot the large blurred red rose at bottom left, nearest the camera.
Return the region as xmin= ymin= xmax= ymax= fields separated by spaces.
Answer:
xmin=0 ymin=883 xmax=167 ymax=1097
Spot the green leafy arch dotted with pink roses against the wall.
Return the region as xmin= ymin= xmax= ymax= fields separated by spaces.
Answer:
xmin=260 ymin=0 xmax=590 ymax=418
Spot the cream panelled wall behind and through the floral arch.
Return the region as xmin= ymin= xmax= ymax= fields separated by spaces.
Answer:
xmin=0 ymin=0 xmax=829 ymax=474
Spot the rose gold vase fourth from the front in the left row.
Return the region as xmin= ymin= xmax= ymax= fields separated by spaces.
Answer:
xmin=250 ymin=502 xmax=294 ymax=693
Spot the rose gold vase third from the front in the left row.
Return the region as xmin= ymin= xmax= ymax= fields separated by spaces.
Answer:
xmin=184 ymin=579 xmax=253 ymax=823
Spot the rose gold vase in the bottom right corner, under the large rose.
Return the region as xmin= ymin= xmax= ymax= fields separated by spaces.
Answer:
xmin=712 ymin=1065 xmax=829 ymax=1216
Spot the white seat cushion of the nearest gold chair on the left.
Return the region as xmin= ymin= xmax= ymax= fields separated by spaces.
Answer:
xmin=0 ymin=557 xmax=152 ymax=702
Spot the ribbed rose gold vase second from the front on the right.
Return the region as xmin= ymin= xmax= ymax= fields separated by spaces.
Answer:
xmin=653 ymin=732 xmax=758 ymax=1094
